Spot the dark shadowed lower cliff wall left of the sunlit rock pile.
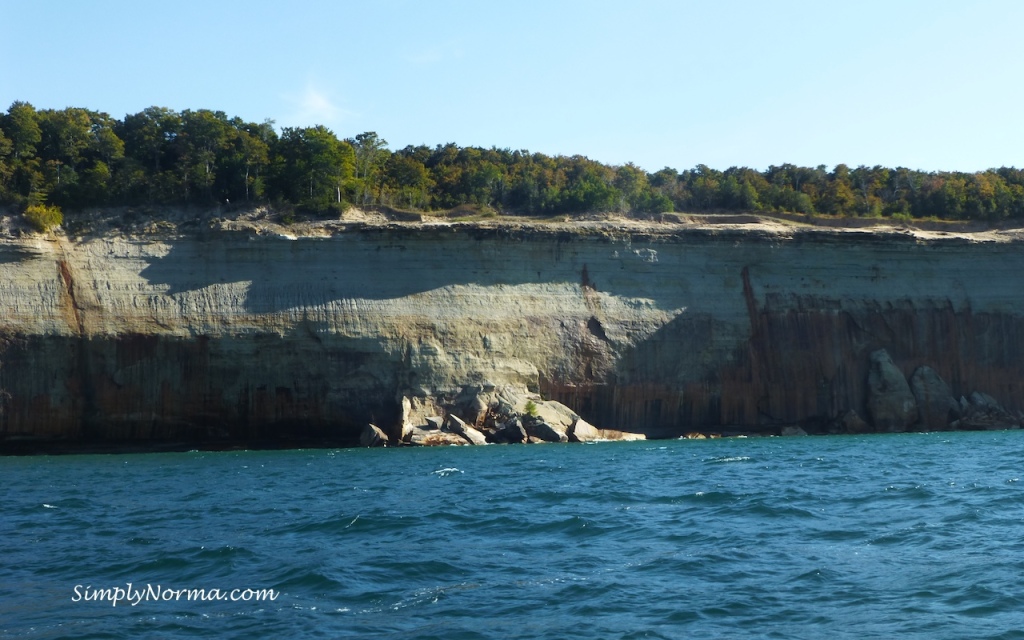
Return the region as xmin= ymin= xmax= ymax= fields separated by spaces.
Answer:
xmin=0 ymin=326 xmax=402 ymax=446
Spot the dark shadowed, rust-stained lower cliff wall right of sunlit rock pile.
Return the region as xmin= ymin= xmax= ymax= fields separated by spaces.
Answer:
xmin=542 ymin=293 xmax=1024 ymax=437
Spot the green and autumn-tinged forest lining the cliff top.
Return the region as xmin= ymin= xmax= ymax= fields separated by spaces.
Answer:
xmin=0 ymin=101 xmax=1024 ymax=222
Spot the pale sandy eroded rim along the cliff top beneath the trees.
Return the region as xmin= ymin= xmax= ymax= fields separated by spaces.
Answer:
xmin=0 ymin=207 xmax=1024 ymax=244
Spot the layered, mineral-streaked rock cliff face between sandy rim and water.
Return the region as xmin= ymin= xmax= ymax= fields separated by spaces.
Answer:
xmin=0 ymin=219 xmax=1024 ymax=440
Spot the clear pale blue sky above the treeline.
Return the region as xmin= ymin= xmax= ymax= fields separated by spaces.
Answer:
xmin=0 ymin=0 xmax=1024 ymax=171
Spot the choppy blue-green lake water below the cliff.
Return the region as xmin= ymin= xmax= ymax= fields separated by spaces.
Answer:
xmin=0 ymin=431 xmax=1024 ymax=639
